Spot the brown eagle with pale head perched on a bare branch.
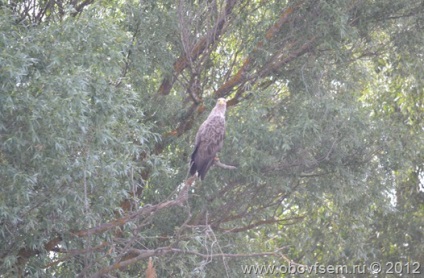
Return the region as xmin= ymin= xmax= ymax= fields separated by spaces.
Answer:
xmin=190 ymin=98 xmax=227 ymax=180
